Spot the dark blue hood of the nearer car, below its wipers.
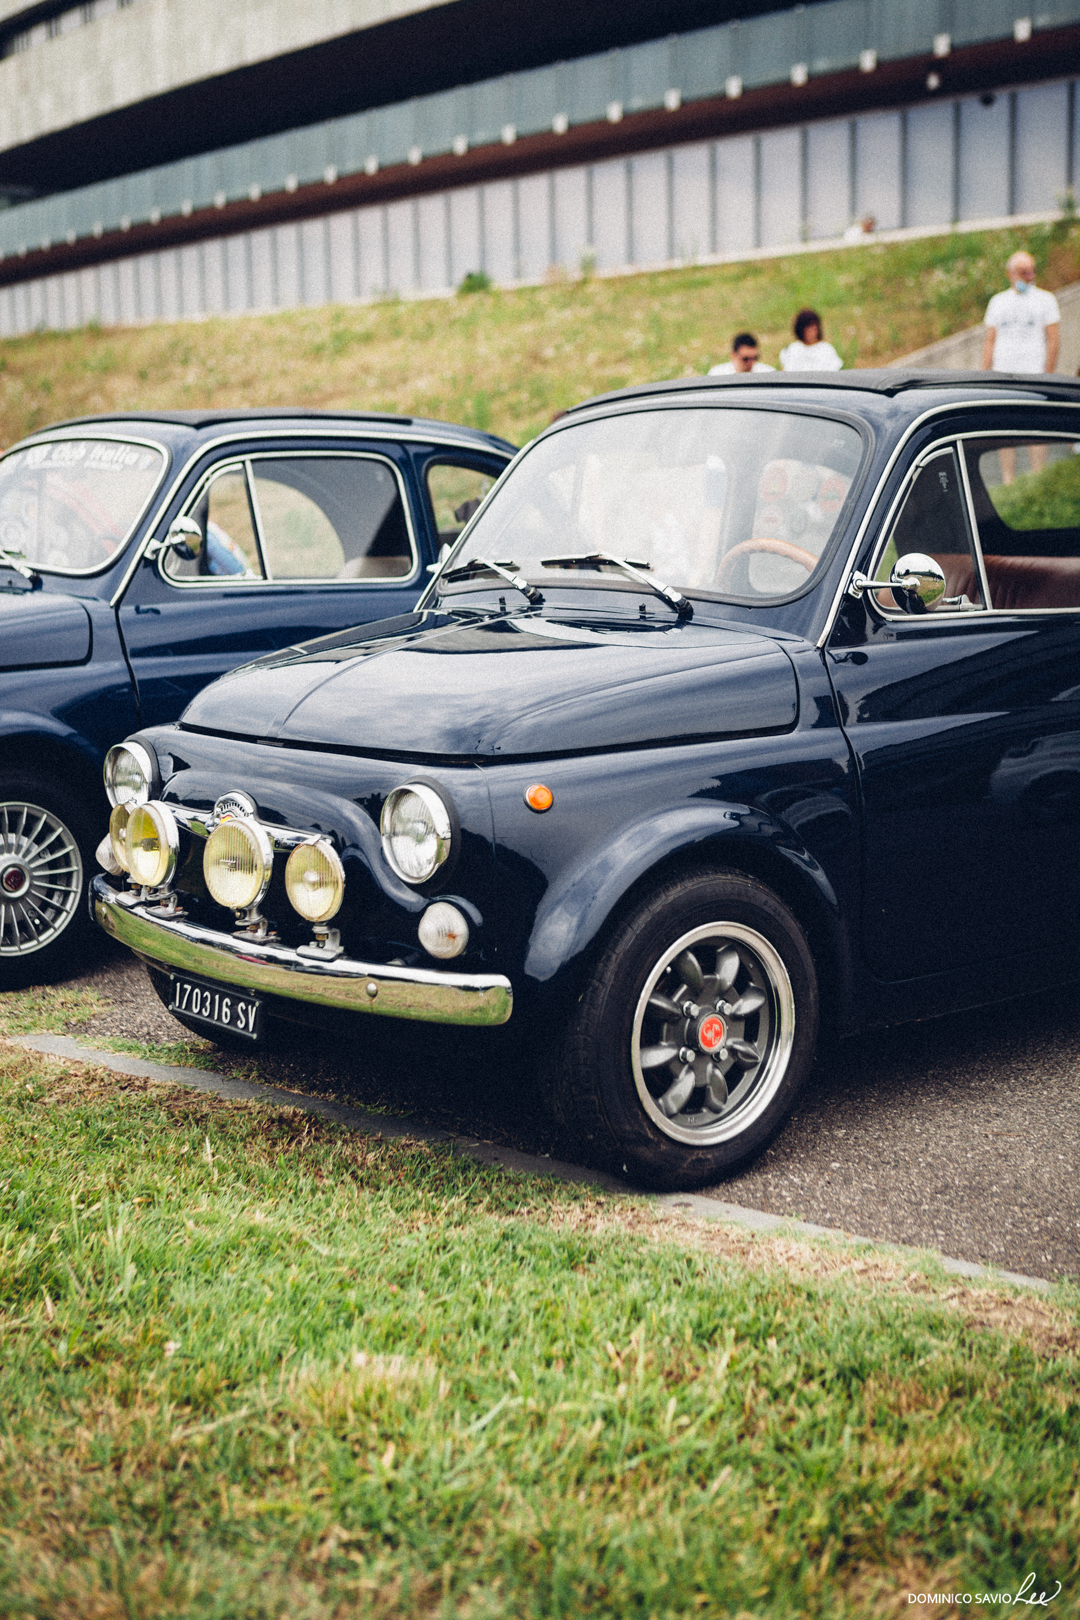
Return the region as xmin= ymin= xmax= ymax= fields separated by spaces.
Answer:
xmin=183 ymin=614 xmax=798 ymax=758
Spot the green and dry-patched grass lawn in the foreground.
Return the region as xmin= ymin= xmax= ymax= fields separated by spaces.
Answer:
xmin=0 ymin=1030 xmax=1080 ymax=1620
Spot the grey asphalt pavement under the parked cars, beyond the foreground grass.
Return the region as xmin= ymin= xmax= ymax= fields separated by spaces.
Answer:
xmin=29 ymin=943 xmax=1080 ymax=1278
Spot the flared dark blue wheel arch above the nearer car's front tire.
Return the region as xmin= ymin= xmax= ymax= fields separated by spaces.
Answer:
xmin=525 ymin=804 xmax=852 ymax=1025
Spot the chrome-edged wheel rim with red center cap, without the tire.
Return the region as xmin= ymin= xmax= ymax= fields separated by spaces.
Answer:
xmin=630 ymin=922 xmax=795 ymax=1147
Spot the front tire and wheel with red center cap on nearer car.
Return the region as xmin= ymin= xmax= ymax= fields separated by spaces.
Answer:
xmin=549 ymin=872 xmax=818 ymax=1189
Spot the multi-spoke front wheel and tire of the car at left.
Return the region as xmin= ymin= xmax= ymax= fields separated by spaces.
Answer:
xmin=0 ymin=771 xmax=97 ymax=990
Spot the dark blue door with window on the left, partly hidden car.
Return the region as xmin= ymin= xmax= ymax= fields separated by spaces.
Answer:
xmin=118 ymin=447 xmax=429 ymax=726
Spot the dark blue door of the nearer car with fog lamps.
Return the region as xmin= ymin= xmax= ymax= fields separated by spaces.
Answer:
xmin=827 ymin=407 xmax=1080 ymax=982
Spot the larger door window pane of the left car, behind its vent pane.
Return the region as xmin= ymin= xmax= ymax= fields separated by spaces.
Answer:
xmin=251 ymin=455 xmax=415 ymax=580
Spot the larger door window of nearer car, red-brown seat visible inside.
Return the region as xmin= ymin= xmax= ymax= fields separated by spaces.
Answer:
xmin=967 ymin=434 xmax=1080 ymax=612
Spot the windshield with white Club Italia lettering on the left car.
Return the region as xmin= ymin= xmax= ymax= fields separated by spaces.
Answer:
xmin=0 ymin=439 xmax=165 ymax=573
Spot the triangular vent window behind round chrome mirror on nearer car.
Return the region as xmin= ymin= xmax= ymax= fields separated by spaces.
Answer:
xmin=874 ymin=446 xmax=984 ymax=612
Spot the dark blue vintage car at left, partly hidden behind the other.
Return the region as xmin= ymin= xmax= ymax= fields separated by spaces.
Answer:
xmin=0 ymin=410 xmax=513 ymax=990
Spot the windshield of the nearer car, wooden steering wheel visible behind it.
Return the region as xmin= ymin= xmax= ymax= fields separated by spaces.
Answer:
xmin=440 ymin=407 xmax=863 ymax=603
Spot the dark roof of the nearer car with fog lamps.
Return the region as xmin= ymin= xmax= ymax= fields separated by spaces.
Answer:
xmin=570 ymin=366 xmax=1080 ymax=411
